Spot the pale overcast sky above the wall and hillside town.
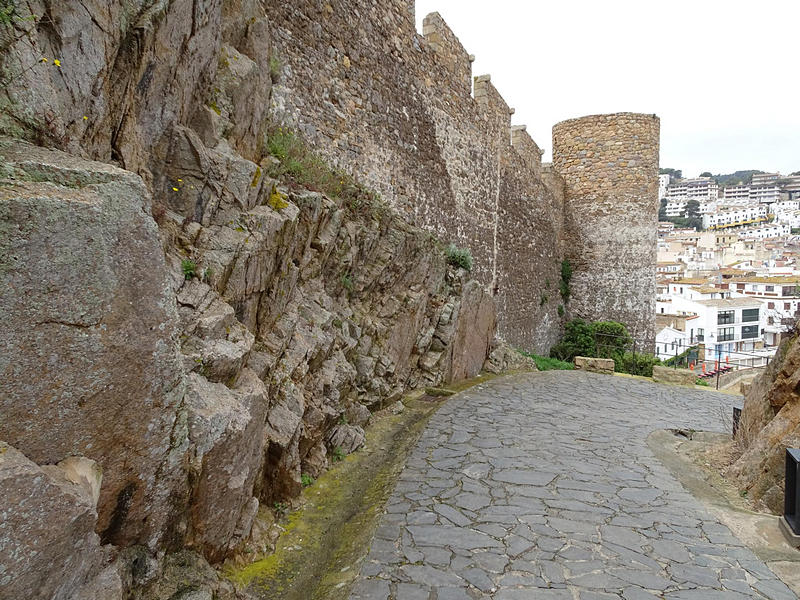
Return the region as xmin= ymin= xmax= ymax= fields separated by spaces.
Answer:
xmin=416 ymin=0 xmax=800 ymax=176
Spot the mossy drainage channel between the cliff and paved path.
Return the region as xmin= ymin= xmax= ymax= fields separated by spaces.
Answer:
xmin=226 ymin=376 xmax=493 ymax=600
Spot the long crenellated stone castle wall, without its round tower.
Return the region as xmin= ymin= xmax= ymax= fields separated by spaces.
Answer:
xmin=266 ymin=0 xmax=562 ymax=352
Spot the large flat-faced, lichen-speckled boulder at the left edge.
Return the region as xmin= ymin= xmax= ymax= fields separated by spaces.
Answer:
xmin=0 ymin=140 xmax=186 ymax=544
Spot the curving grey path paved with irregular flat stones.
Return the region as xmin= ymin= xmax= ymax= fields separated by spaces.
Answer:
xmin=350 ymin=371 xmax=796 ymax=600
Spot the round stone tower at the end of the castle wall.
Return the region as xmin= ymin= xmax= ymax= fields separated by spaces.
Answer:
xmin=553 ymin=113 xmax=659 ymax=352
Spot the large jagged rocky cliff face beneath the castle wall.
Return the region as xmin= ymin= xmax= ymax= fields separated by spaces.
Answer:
xmin=0 ymin=0 xmax=495 ymax=599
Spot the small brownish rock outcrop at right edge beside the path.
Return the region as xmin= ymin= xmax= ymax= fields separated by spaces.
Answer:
xmin=731 ymin=337 xmax=800 ymax=514
